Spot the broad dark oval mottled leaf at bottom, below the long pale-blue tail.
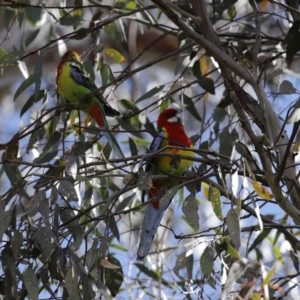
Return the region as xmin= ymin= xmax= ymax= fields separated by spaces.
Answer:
xmin=105 ymin=254 xmax=124 ymax=297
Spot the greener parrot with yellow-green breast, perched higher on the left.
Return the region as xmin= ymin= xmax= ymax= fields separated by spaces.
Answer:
xmin=56 ymin=51 xmax=124 ymax=158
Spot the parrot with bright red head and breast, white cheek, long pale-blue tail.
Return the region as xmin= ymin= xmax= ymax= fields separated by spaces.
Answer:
xmin=137 ymin=108 xmax=194 ymax=260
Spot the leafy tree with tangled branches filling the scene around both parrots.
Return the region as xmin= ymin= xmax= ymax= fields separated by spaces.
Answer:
xmin=0 ymin=0 xmax=300 ymax=299
